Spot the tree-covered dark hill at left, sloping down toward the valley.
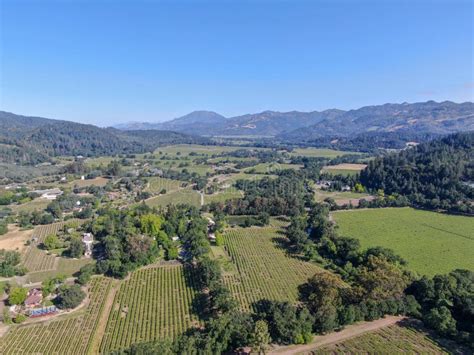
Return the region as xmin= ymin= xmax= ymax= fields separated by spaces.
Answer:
xmin=0 ymin=111 xmax=206 ymax=164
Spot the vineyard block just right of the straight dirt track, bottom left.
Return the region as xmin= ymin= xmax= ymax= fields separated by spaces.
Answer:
xmin=100 ymin=264 xmax=198 ymax=353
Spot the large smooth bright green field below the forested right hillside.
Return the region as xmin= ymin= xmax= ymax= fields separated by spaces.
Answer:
xmin=332 ymin=208 xmax=474 ymax=276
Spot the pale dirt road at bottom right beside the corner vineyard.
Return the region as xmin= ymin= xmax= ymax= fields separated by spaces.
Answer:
xmin=269 ymin=316 xmax=405 ymax=354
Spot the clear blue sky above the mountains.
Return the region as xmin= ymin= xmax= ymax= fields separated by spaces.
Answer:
xmin=0 ymin=0 xmax=474 ymax=126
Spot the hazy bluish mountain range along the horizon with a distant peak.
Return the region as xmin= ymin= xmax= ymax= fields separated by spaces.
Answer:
xmin=116 ymin=101 xmax=474 ymax=142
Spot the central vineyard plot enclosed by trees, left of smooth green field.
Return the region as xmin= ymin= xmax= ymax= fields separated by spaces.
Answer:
xmin=224 ymin=228 xmax=322 ymax=310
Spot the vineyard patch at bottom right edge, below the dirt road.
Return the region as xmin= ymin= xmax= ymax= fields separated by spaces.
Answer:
xmin=310 ymin=325 xmax=454 ymax=355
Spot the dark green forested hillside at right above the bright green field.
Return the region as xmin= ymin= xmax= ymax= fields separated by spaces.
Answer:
xmin=360 ymin=132 xmax=474 ymax=214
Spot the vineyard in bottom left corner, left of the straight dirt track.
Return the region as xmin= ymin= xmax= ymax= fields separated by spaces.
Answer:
xmin=0 ymin=277 xmax=112 ymax=354
